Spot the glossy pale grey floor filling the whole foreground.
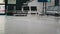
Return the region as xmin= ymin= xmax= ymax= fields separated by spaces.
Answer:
xmin=0 ymin=15 xmax=60 ymax=34
